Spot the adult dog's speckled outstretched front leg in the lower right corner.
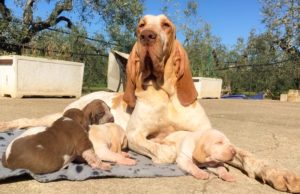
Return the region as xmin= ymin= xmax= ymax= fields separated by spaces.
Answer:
xmin=227 ymin=147 xmax=300 ymax=193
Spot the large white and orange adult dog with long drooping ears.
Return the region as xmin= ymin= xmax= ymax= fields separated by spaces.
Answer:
xmin=0 ymin=15 xmax=300 ymax=192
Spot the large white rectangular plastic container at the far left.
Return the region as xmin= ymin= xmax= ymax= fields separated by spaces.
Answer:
xmin=0 ymin=55 xmax=84 ymax=98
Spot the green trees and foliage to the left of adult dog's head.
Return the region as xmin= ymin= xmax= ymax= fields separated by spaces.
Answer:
xmin=0 ymin=0 xmax=143 ymax=90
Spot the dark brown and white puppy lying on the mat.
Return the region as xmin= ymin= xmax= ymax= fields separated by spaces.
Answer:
xmin=2 ymin=100 xmax=113 ymax=174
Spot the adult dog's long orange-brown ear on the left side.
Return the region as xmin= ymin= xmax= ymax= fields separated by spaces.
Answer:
xmin=123 ymin=44 xmax=138 ymax=108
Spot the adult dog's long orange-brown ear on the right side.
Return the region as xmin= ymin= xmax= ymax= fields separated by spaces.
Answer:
xmin=174 ymin=40 xmax=198 ymax=106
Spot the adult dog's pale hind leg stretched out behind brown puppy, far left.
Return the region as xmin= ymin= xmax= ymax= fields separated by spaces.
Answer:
xmin=0 ymin=113 xmax=62 ymax=132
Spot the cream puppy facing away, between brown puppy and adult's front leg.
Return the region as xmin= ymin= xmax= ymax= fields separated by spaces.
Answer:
xmin=89 ymin=123 xmax=136 ymax=165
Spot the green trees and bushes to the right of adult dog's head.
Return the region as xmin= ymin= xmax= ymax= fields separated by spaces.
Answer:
xmin=164 ymin=0 xmax=300 ymax=97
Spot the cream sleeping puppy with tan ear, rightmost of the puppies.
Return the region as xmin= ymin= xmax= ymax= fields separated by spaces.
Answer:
xmin=162 ymin=129 xmax=236 ymax=182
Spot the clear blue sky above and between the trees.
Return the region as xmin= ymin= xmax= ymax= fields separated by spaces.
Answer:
xmin=7 ymin=0 xmax=264 ymax=47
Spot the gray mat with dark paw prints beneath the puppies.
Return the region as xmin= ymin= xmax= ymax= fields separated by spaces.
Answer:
xmin=0 ymin=130 xmax=186 ymax=182
